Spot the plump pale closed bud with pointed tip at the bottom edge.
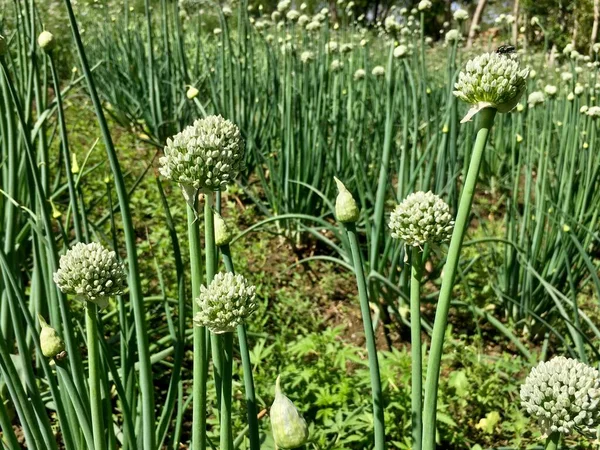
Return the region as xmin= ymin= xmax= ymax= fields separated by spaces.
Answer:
xmin=270 ymin=375 xmax=308 ymax=449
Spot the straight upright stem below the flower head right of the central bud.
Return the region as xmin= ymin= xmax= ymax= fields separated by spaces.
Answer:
xmin=410 ymin=247 xmax=423 ymax=450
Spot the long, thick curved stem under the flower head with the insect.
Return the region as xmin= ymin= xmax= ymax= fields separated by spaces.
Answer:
xmin=423 ymin=108 xmax=496 ymax=450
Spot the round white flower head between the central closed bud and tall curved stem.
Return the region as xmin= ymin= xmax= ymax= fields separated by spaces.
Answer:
xmin=389 ymin=191 xmax=454 ymax=247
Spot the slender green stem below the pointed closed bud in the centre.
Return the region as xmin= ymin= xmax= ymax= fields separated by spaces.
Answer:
xmin=346 ymin=223 xmax=385 ymax=450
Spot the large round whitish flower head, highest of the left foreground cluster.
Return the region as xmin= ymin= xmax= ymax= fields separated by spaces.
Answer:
xmin=160 ymin=116 xmax=244 ymax=191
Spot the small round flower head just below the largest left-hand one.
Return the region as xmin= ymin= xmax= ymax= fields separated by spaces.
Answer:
xmin=194 ymin=272 xmax=257 ymax=334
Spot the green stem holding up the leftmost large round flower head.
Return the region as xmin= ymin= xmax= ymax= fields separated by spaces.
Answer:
xmin=85 ymin=302 xmax=106 ymax=450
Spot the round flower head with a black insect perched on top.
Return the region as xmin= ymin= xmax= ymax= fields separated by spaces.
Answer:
xmin=454 ymin=52 xmax=528 ymax=122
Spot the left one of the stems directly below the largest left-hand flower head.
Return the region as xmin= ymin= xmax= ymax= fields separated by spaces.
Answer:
xmin=187 ymin=206 xmax=208 ymax=450
